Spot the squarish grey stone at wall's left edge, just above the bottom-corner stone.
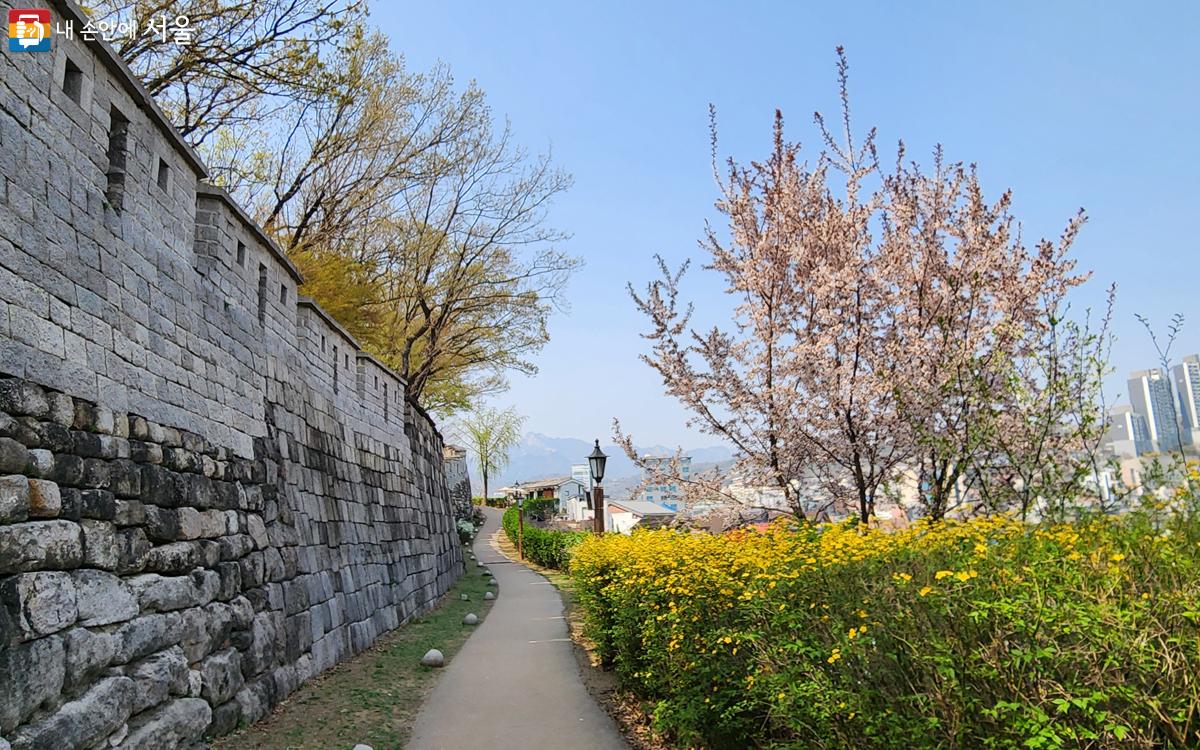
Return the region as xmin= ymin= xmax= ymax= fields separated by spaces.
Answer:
xmin=0 ymin=636 xmax=66 ymax=733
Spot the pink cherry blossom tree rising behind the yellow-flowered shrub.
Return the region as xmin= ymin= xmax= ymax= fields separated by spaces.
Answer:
xmin=617 ymin=48 xmax=1086 ymax=522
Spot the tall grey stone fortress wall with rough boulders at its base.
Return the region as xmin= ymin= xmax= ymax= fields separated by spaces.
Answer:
xmin=0 ymin=0 xmax=462 ymax=750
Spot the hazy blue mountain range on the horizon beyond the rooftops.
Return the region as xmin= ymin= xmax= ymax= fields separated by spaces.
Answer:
xmin=468 ymin=432 xmax=733 ymax=498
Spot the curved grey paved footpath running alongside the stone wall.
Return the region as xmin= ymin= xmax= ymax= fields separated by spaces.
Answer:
xmin=408 ymin=508 xmax=629 ymax=750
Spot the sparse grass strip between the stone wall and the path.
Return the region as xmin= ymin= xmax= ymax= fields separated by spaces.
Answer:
xmin=212 ymin=559 xmax=494 ymax=750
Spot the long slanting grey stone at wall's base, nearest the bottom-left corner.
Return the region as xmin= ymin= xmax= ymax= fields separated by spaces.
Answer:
xmin=12 ymin=677 xmax=133 ymax=750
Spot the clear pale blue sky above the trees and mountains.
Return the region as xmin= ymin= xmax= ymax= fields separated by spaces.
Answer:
xmin=372 ymin=1 xmax=1200 ymax=446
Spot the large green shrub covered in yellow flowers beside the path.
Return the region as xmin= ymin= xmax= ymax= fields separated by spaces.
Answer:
xmin=571 ymin=506 xmax=1200 ymax=749
